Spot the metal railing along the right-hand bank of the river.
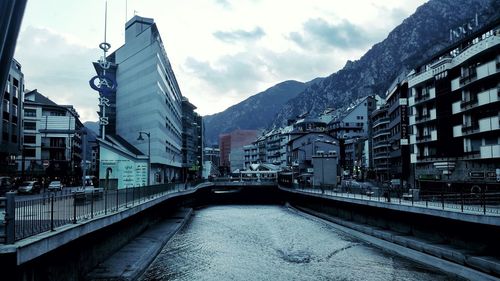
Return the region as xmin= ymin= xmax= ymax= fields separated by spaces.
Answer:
xmin=282 ymin=184 xmax=500 ymax=216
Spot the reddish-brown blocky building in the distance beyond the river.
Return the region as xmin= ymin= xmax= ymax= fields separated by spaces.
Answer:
xmin=219 ymin=130 xmax=260 ymax=175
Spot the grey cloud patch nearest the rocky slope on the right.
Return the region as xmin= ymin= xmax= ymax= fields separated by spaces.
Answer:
xmin=288 ymin=18 xmax=373 ymax=50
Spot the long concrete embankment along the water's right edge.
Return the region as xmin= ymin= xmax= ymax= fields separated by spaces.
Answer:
xmin=292 ymin=203 xmax=500 ymax=281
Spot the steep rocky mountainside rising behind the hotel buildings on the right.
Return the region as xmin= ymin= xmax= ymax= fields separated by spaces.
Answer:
xmin=272 ymin=0 xmax=500 ymax=126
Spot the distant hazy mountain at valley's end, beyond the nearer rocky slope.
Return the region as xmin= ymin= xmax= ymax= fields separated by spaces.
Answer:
xmin=203 ymin=78 xmax=322 ymax=145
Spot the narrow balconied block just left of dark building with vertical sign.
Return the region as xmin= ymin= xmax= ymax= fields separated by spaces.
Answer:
xmin=371 ymin=105 xmax=391 ymax=181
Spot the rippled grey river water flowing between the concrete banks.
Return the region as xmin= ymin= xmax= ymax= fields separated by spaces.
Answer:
xmin=141 ymin=206 xmax=456 ymax=281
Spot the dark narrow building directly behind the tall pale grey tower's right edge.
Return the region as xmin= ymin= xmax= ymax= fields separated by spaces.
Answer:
xmin=182 ymin=97 xmax=203 ymax=179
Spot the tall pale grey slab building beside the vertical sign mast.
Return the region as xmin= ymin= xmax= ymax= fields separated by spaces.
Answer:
xmin=102 ymin=16 xmax=185 ymax=183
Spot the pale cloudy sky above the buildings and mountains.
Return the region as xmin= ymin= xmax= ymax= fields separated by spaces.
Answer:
xmin=15 ymin=0 xmax=426 ymax=121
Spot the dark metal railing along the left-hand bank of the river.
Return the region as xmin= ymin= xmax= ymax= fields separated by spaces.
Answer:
xmin=0 ymin=181 xmax=203 ymax=244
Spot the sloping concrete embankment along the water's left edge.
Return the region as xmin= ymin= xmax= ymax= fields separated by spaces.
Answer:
xmin=86 ymin=208 xmax=193 ymax=281
